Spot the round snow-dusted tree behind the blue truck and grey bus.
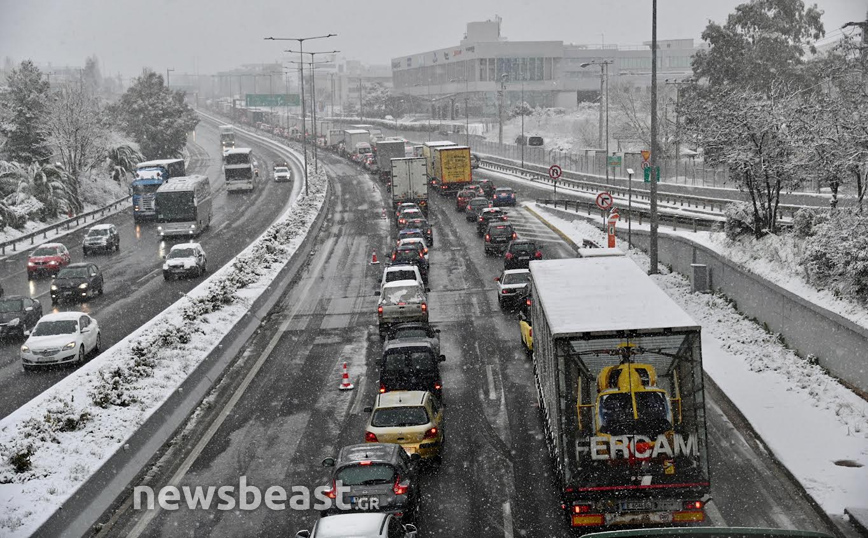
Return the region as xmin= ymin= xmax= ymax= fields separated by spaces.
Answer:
xmin=112 ymin=71 xmax=199 ymax=159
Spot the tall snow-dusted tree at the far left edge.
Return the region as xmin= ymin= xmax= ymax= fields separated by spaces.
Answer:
xmin=0 ymin=60 xmax=51 ymax=163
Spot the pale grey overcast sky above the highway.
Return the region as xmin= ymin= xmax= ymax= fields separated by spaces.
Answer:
xmin=0 ymin=0 xmax=868 ymax=76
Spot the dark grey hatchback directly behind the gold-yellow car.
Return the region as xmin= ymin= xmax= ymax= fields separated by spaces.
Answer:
xmin=322 ymin=443 xmax=419 ymax=522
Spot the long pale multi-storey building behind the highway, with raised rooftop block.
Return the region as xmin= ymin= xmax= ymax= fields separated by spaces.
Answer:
xmin=392 ymin=17 xmax=699 ymax=119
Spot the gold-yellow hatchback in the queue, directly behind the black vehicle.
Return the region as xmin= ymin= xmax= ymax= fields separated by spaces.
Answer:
xmin=365 ymin=390 xmax=445 ymax=461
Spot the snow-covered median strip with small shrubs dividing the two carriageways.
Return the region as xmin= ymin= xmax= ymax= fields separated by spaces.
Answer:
xmin=0 ymin=165 xmax=327 ymax=537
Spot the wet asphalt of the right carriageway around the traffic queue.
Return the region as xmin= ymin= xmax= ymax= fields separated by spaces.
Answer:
xmin=93 ymin=142 xmax=831 ymax=537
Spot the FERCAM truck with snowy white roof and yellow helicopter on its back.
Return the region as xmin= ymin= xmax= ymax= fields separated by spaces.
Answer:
xmin=529 ymin=255 xmax=710 ymax=529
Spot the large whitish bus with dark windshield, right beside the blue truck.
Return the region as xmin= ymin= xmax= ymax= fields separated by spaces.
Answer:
xmin=156 ymin=175 xmax=211 ymax=237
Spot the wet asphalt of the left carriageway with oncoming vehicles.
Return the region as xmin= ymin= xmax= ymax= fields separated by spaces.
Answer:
xmin=0 ymin=120 xmax=301 ymax=418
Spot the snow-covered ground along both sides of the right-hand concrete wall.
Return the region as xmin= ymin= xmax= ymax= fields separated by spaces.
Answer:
xmin=526 ymin=204 xmax=868 ymax=514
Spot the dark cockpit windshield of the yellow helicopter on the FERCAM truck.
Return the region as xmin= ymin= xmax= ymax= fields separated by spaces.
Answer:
xmin=600 ymin=391 xmax=672 ymax=439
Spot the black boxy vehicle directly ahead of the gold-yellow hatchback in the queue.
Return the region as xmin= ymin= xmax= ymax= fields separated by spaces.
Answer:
xmin=380 ymin=340 xmax=446 ymax=398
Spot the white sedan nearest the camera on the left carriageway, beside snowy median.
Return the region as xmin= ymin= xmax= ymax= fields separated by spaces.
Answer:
xmin=21 ymin=312 xmax=102 ymax=370
